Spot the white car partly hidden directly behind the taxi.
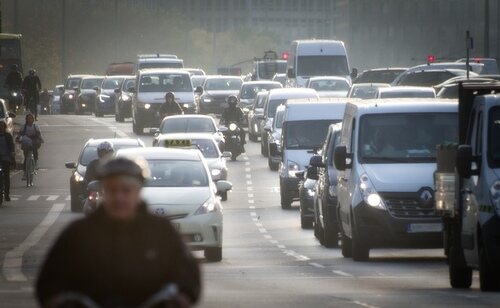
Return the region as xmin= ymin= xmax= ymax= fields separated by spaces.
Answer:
xmin=156 ymin=133 xmax=231 ymax=201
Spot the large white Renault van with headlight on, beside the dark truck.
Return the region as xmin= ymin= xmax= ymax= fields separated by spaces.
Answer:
xmin=334 ymin=99 xmax=458 ymax=261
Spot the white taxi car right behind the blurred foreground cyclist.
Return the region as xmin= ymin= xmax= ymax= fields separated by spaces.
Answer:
xmin=116 ymin=147 xmax=232 ymax=262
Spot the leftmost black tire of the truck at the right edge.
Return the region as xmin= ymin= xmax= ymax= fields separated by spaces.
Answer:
xmin=448 ymin=246 xmax=472 ymax=289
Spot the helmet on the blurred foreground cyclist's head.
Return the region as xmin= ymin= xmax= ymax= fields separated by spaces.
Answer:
xmin=98 ymin=158 xmax=149 ymax=183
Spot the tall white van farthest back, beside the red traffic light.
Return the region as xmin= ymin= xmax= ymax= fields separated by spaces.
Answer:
xmin=287 ymin=40 xmax=351 ymax=88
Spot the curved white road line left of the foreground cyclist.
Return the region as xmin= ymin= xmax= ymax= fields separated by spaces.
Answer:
xmin=2 ymin=203 xmax=65 ymax=281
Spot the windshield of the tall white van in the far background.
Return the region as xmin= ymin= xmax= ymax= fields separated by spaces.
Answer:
xmin=297 ymin=56 xmax=349 ymax=77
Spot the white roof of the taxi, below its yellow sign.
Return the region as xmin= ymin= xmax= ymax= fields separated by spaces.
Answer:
xmin=116 ymin=147 xmax=203 ymax=161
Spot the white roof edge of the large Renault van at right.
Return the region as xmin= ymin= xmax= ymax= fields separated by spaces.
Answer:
xmin=347 ymin=98 xmax=458 ymax=115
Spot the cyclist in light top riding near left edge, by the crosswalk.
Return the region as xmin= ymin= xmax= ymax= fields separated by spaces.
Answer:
xmin=17 ymin=113 xmax=43 ymax=181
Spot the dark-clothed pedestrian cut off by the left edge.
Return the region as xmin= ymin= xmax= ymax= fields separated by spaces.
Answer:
xmin=0 ymin=121 xmax=16 ymax=201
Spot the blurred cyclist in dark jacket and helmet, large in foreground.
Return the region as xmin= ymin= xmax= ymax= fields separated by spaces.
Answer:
xmin=36 ymin=158 xmax=201 ymax=307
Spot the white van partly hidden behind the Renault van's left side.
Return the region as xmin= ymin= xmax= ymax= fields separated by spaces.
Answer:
xmin=269 ymin=98 xmax=347 ymax=209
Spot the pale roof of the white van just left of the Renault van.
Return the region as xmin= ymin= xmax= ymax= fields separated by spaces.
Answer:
xmin=284 ymin=99 xmax=347 ymax=122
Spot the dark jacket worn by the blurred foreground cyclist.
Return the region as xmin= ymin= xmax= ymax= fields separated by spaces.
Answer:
xmin=36 ymin=204 xmax=201 ymax=307
